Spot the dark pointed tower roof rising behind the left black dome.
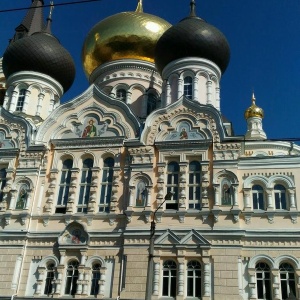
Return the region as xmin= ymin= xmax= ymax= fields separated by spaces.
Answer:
xmin=13 ymin=0 xmax=44 ymax=41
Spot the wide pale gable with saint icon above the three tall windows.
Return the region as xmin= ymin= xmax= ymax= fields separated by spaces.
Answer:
xmin=37 ymin=85 xmax=140 ymax=143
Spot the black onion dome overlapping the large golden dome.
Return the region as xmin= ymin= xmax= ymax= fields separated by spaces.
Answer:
xmin=155 ymin=15 xmax=230 ymax=73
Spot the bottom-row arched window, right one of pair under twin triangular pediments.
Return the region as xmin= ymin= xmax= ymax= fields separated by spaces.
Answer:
xmin=187 ymin=260 xmax=201 ymax=298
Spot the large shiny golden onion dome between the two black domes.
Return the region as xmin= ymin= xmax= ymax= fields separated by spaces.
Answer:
xmin=82 ymin=0 xmax=171 ymax=77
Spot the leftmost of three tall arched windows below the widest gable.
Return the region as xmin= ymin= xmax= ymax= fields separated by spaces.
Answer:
xmin=55 ymin=159 xmax=73 ymax=213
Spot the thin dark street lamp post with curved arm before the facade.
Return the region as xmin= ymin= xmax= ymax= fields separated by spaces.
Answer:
xmin=145 ymin=191 xmax=175 ymax=300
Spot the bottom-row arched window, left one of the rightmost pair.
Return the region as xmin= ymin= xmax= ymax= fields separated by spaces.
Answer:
xmin=255 ymin=262 xmax=271 ymax=299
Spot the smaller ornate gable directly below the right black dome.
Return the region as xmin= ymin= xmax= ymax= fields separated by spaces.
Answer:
xmin=141 ymin=97 xmax=226 ymax=145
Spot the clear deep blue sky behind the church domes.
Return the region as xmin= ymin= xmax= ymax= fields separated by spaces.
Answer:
xmin=0 ymin=0 xmax=300 ymax=138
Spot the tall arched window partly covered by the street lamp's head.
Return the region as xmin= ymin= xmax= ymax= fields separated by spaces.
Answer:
xmin=166 ymin=161 xmax=179 ymax=210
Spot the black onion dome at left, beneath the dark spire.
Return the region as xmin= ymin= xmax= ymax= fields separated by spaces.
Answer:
xmin=3 ymin=32 xmax=75 ymax=92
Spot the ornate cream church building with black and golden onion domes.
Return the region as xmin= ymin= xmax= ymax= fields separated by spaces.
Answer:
xmin=0 ymin=0 xmax=300 ymax=300
